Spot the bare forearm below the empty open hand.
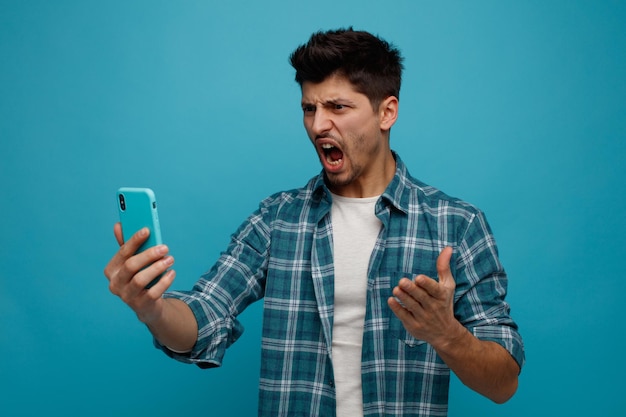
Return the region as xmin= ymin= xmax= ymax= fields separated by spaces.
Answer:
xmin=434 ymin=323 xmax=520 ymax=403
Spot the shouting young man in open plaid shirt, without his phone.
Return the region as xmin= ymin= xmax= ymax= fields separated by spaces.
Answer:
xmin=105 ymin=29 xmax=524 ymax=417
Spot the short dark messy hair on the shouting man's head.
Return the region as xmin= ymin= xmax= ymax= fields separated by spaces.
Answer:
xmin=289 ymin=27 xmax=403 ymax=108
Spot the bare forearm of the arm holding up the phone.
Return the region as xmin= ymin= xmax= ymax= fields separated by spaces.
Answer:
xmin=140 ymin=298 xmax=198 ymax=352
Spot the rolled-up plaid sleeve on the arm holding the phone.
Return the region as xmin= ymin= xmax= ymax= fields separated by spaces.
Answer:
xmin=154 ymin=209 xmax=269 ymax=368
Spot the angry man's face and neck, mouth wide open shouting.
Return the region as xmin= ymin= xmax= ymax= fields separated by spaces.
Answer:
xmin=302 ymin=75 xmax=395 ymax=197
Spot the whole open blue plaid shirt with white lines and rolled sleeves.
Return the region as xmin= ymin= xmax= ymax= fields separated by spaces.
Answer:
xmin=156 ymin=155 xmax=524 ymax=417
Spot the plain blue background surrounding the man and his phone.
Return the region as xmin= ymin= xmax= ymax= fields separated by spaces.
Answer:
xmin=0 ymin=0 xmax=626 ymax=417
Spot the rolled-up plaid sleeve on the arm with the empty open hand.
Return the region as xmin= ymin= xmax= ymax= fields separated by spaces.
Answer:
xmin=455 ymin=211 xmax=525 ymax=369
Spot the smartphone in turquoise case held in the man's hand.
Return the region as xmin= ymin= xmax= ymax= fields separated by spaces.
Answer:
xmin=117 ymin=187 xmax=162 ymax=288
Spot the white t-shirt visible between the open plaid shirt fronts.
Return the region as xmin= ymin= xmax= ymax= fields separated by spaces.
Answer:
xmin=331 ymin=194 xmax=382 ymax=417
